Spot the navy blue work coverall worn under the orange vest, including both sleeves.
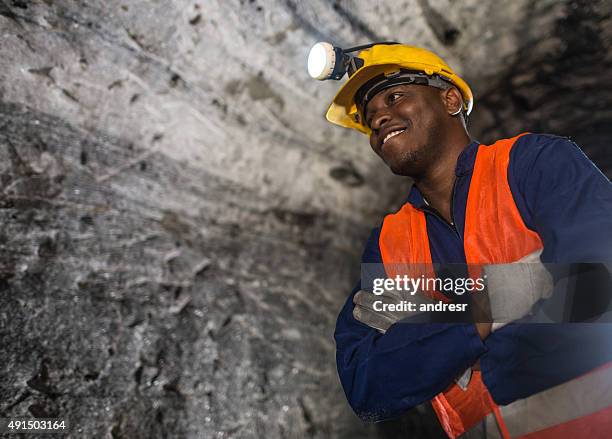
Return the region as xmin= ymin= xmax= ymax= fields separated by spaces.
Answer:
xmin=335 ymin=134 xmax=612 ymax=420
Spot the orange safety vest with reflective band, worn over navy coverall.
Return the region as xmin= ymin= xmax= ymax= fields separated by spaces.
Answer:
xmin=379 ymin=133 xmax=612 ymax=439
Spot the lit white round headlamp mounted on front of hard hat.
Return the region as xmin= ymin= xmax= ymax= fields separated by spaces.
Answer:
xmin=308 ymin=41 xmax=399 ymax=81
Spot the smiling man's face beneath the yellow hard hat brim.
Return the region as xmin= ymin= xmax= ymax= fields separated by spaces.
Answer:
xmin=365 ymin=84 xmax=448 ymax=178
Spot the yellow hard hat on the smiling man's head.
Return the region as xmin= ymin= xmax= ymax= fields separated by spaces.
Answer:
xmin=326 ymin=44 xmax=474 ymax=135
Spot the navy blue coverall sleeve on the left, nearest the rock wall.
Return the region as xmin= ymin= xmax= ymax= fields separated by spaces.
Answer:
xmin=335 ymin=229 xmax=486 ymax=421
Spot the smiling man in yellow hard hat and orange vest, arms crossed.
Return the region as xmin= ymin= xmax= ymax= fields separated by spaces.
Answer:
xmin=318 ymin=43 xmax=612 ymax=438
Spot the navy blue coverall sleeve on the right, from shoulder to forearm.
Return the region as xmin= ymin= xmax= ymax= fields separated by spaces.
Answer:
xmin=480 ymin=134 xmax=612 ymax=404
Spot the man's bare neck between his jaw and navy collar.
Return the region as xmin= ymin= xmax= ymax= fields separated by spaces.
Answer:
xmin=415 ymin=133 xmax=471 ymax=223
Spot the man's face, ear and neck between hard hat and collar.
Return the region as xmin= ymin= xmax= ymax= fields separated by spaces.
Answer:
xmin=357 ymin=78 xmax=470 ymax=227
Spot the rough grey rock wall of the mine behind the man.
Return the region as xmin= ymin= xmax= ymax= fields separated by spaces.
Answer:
xmin=0 ymin=0 xmax=612 ymax=438
